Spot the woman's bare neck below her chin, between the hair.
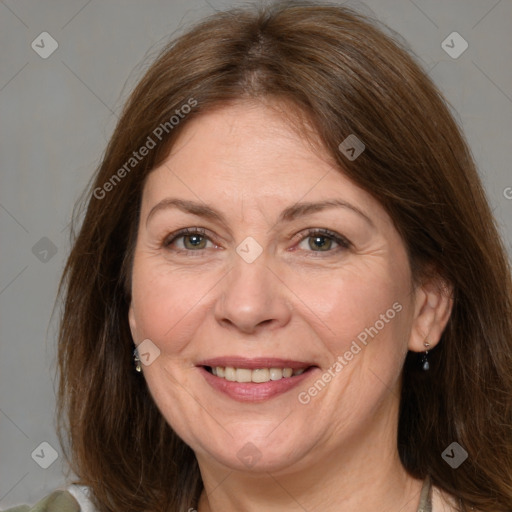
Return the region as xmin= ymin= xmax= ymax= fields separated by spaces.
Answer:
xmin=198 ymin=400 xmax=423 ymax=512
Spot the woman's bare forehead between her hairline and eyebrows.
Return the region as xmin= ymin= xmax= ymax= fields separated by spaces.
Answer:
xmin=144 ymin=101 xmax=373 ymax=213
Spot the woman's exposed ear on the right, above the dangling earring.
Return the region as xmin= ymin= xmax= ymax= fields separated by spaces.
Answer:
xmin=408 ymin=278 xmax=453 ymax=352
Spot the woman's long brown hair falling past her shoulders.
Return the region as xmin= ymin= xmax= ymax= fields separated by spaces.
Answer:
xmin=58 ymin=2 xmax=512 ymax=512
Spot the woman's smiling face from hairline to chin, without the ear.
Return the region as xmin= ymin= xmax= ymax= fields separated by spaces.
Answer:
xmin=130 ymin=102 xmax=422 ymax=471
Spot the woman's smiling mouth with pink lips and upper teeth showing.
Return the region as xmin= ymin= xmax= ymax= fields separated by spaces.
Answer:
xmin=197 ymin=357 xmax=318 ymax=402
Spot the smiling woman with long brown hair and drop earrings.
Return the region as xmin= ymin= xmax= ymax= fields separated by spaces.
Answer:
xmin=8 ymin=2 xmax=512 ymax=512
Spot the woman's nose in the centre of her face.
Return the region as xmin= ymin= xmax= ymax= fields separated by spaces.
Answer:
xmin=214 ymin=255 xmax=292 ymax=334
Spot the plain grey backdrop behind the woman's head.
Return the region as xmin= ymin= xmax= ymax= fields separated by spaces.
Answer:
xmin=0 ymin=0 xmax=512 ymax=509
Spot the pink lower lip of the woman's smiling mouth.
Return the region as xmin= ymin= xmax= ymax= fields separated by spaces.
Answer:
xmin=199 ymin=366 xmax=315 ymax=402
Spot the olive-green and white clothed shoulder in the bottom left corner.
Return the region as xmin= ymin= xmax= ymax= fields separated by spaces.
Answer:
xmin=5 ymin=485 xmax=96 ymax=512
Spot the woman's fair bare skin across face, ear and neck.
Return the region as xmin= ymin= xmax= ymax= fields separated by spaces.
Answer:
xmin=129 ymin=101 xmax=452 ymax=512
